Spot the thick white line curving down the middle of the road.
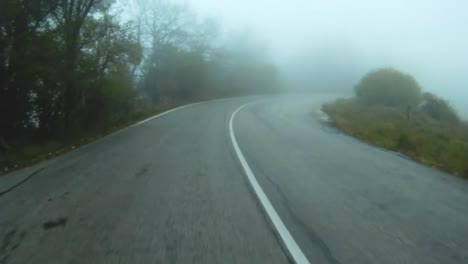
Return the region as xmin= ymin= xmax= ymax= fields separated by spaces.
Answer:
xmin=229 ymin=104 xmax=310 ymax=264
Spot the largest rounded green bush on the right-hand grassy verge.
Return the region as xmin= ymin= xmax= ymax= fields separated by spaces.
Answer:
xmin=355 ymin=68 xmax=421 ymax=107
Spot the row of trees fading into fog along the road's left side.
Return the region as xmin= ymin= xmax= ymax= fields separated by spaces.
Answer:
xmin=0 ymin=0 xmax=279 ymax=148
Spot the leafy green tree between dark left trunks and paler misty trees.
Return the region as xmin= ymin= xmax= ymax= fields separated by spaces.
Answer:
xmin=78 ymin=12 xmax=142 ymax=127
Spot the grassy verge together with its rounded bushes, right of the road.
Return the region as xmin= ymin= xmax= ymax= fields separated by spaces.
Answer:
xmin=322 ymin=68 xmax=468 ymax=178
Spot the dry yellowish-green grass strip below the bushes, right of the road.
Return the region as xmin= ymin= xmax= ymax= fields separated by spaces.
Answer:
xmin=322 ymin=99 xmax=468 ymax=178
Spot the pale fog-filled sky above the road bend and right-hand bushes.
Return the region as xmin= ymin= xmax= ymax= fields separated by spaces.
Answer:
xmin=166 ymin=0 xmax=468 ymax=117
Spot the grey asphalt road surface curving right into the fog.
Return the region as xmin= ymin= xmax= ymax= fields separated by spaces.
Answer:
xmin=0 ymin=95 xmax=468 ymax=264
